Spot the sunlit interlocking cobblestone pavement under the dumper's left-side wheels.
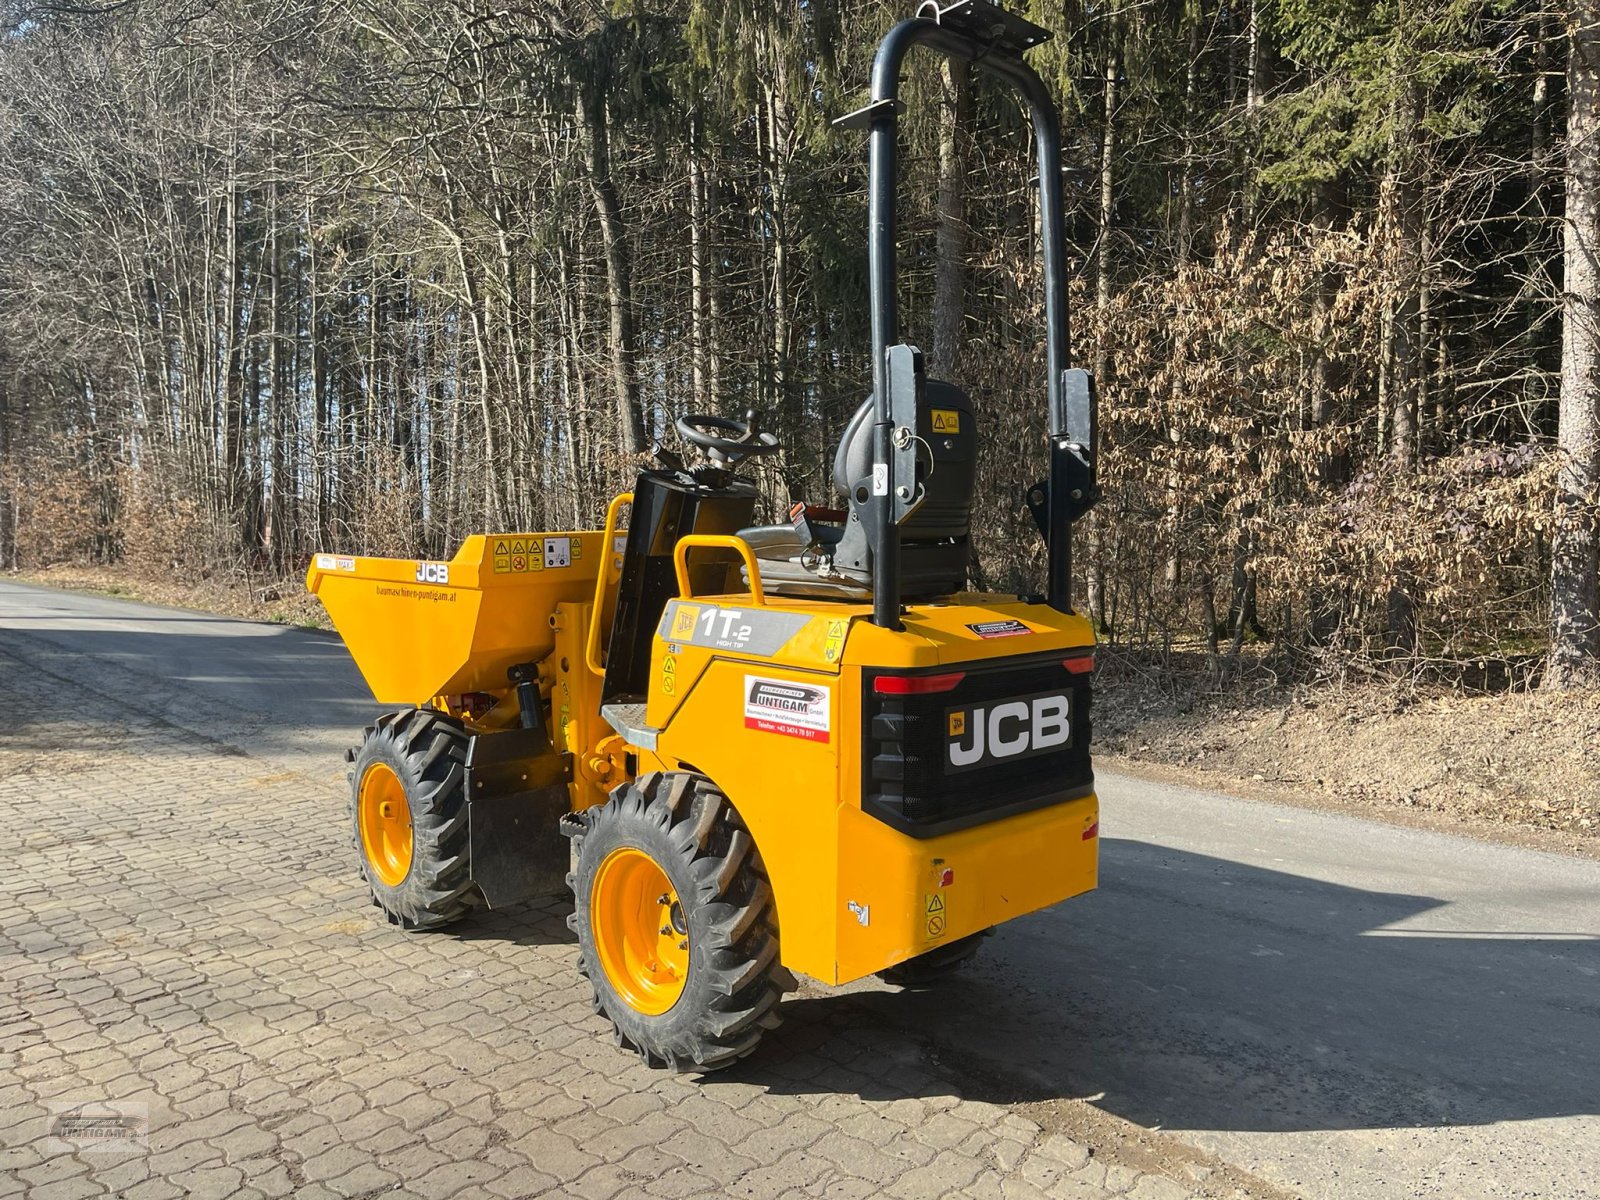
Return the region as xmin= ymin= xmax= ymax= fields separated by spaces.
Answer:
xmin=0 ymin=643 xmax=1229 ymax=1200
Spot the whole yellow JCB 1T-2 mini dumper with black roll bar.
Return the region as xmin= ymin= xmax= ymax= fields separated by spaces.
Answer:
xmin=307 ymin=0 xmax=1099 ymax=1070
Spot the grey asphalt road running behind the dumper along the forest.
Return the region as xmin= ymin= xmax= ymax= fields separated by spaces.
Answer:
xmin=0 ymin=584 xmax=1600 ymax=1198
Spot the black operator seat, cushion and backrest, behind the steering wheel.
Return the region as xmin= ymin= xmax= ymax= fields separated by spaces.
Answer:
xmin=739 ymin=379 xmax=978 ymax=600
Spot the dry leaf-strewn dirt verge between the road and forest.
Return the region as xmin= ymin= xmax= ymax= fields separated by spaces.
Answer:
xmin=16 ymin=566 xmax=1600 ymax=856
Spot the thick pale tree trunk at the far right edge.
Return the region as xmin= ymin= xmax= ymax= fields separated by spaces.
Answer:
xmin=1544 ymin=0 xmax=1600 ymax=688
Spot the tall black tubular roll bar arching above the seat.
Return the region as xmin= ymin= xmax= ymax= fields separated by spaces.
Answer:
xmin=840 ymin=0 xmax=1093 ymax=629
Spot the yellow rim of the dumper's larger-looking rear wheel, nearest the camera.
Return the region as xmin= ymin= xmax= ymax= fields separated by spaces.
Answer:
xmin=589 ymin=846 xmax=690 ymax=1016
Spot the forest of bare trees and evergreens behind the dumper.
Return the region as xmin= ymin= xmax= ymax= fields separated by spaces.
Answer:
xmin=0 ymin=0 xmax=1600 ymax=688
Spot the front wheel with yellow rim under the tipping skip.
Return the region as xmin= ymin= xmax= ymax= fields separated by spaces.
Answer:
xmin=347 ymin=709 xmax=477 ymax=930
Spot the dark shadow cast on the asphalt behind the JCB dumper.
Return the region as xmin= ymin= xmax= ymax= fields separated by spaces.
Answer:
xmin=732 ymin=838 xmax=1600 ymax=1131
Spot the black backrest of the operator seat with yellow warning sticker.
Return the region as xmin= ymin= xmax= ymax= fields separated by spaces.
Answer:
xmin=834 ymin=379 xmax=978 ymax=544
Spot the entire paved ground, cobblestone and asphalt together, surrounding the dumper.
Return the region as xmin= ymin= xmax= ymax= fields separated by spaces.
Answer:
xmin=0 ymin=584 xmax=1600 ymax=1200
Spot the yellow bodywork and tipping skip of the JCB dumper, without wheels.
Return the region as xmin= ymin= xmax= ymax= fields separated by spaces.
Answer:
xmin=307 ymin=531 xmax=1099 ymax=984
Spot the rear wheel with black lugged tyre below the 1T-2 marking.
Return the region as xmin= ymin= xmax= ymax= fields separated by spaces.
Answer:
xmin=563 ymin=771 xmax=795 ymax=1070
